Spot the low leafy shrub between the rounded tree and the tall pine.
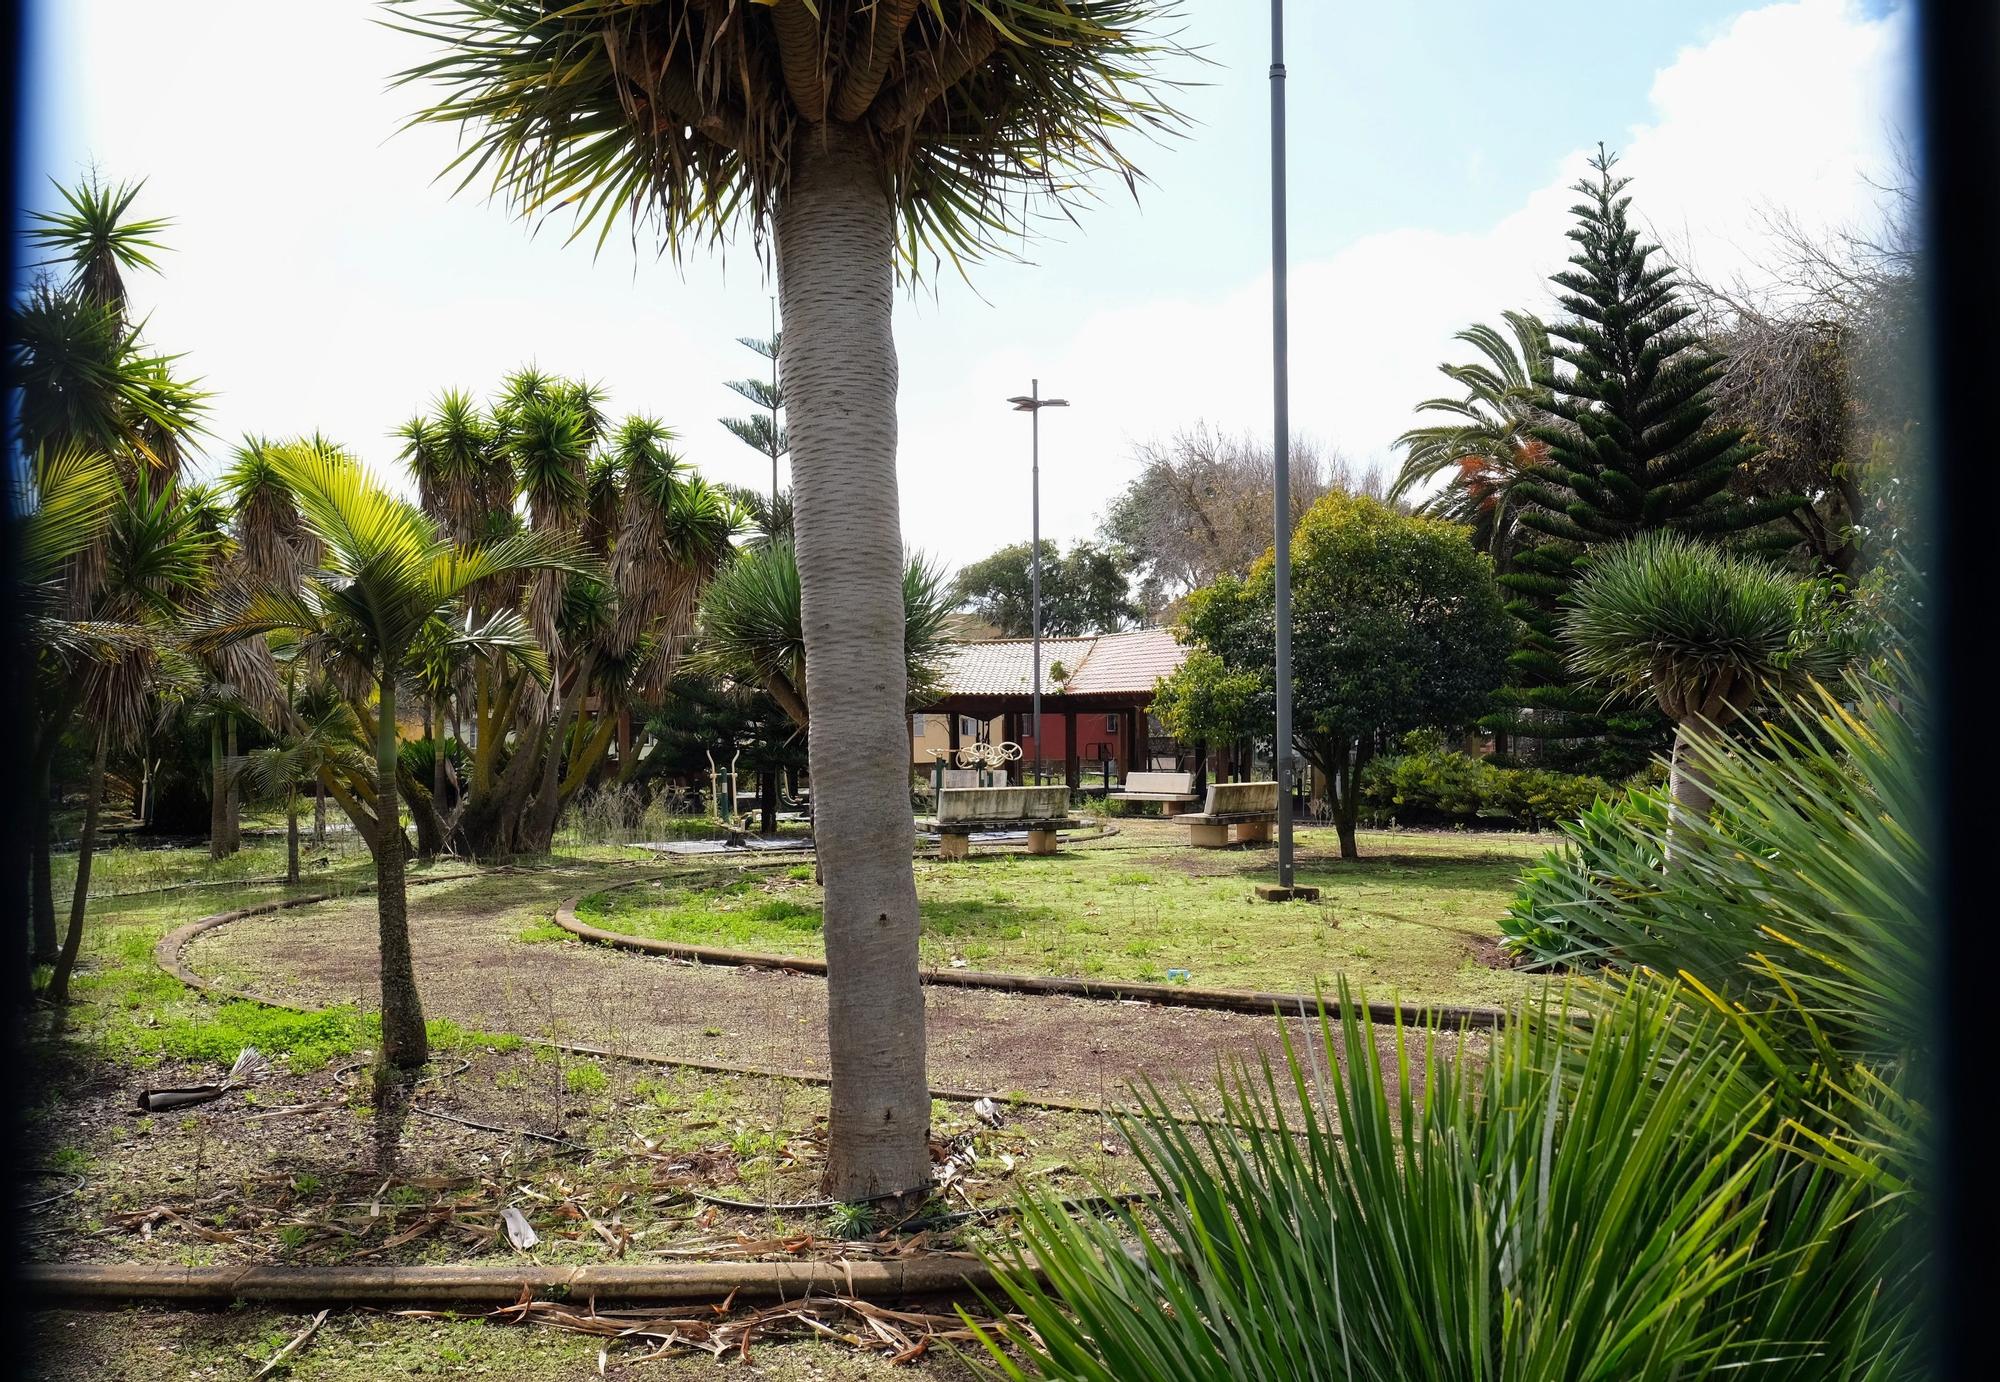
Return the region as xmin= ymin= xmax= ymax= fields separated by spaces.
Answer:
xmin=1360 ymin=732 xmax=1614 ymax=830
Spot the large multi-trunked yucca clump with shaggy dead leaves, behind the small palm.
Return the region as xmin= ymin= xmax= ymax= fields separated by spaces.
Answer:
xmin=400 ymin=366 xmax=740 ymax=858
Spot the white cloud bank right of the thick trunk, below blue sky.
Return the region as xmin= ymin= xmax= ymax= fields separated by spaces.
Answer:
xmin=902 ymin=0 xmax=1912 ymax=558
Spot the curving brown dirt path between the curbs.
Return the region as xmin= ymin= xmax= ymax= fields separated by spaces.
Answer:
xmin=186 ymin=878 xmax=1456 ymax=1102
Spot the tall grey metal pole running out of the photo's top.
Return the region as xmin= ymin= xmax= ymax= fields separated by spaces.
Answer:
xmin=1270 ymin=0 xmax=1292 ymax=888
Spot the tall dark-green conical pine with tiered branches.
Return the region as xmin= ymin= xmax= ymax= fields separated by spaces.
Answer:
xmin=1494 ymin=144 xmax=1802 ymax=776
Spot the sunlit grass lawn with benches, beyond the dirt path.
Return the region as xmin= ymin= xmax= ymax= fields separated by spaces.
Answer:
xmin=578 ymin=820 xmax=1548 ymax=1002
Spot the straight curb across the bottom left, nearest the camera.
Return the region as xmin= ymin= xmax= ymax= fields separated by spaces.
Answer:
xmin=20 ymin=1252 xmax=1024 ymax=1306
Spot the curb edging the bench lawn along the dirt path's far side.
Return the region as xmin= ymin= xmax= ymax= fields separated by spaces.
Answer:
xmin=556 ymin=878 xmax=1506 ymax=1028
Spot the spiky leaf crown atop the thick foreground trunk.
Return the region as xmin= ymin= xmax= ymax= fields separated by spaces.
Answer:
xmin=386 ymin=0 xmax=1192 ymax=276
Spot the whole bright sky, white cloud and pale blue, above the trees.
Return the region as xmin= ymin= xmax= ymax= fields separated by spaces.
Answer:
xmin=28 ymin=0 xmax=1912 ymax=566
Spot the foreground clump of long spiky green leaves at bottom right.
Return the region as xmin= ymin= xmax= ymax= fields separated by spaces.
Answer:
xmin=990 ymin=980 xmax=1908 ymax=1382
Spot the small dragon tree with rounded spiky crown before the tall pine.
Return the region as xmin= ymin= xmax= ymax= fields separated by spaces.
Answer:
xmin=1562 ymin=530 xmax=1852 ymax=866
